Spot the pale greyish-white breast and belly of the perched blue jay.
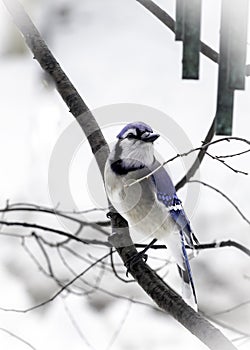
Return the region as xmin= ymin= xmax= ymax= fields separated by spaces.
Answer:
xmin=105 ymin=162 xmax=178 ymax=242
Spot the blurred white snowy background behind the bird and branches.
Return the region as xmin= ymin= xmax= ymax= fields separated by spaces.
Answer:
xmin=0 ymin=0 xmax=250 ymax=350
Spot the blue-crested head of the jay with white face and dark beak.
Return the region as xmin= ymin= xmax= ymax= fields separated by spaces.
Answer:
xmin=111 ymin=122 xmax=160 ymax=173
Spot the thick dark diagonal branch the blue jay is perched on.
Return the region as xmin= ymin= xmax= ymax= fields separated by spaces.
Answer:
xmin=3 ymin=0 xmax=236 ymax=350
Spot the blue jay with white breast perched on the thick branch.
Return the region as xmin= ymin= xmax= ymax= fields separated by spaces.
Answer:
xmin=104 ymin=122 xmax=198 ymax=309
